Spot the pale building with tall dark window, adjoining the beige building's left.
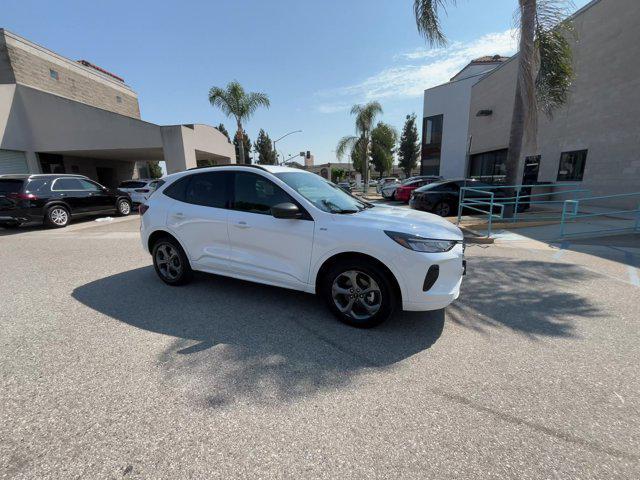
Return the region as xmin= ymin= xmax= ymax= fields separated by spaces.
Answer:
xmin=420 ymin=55 xmax=507 ymax=178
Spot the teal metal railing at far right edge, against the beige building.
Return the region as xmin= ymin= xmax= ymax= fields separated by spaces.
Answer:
xmin=560 ymin=192 xmax=640 ymax=238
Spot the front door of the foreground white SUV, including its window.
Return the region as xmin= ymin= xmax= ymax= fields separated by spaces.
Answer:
xmin=229 ymin=172 xmax=314 ymax=288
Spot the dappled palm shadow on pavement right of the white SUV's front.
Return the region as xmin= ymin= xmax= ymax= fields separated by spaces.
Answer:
xmin=447 ymin=257 xmax=603 ymax=339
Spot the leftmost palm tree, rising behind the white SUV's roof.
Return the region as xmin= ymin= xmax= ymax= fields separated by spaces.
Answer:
xmin=209 ymin=80 xmax=270 ymax=162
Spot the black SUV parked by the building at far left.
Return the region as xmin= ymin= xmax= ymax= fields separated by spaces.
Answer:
xmin=0 ymin=174 xmax=131 ymax=228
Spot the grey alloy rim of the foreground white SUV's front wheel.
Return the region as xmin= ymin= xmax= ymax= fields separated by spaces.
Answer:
xmin=331 ymin=270 xmax=382 ymax=320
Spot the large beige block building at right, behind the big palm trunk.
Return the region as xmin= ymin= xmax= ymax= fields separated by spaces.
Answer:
xmin=464 ymin=0 xmax=640 ymax=208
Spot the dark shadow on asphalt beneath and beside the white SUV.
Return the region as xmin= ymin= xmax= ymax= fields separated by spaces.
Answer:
xmin=73 ymin=267 xmax=445 ymax=407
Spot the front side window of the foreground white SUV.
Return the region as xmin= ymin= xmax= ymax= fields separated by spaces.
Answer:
xmin=233 ymin=172 xmax=293 ymax=215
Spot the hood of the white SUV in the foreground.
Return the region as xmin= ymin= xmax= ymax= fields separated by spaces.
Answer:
xmin=341 ymin=205 xmax=463 ymax=240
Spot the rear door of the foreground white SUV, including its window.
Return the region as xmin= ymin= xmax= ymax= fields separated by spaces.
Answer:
xmin=163 ymin=172 xmax=233 ymax=273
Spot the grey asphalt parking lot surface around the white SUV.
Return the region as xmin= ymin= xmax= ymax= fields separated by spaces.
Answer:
xmin=0 ymin=217 xmax=640 ymax=479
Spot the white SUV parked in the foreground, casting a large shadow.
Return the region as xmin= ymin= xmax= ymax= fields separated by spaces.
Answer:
xmin=140 ymin=165 xmax=465 ymax=327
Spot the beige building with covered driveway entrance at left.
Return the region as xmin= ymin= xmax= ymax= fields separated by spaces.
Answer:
xmin=0 ymin=29 xmax=235 ymax=186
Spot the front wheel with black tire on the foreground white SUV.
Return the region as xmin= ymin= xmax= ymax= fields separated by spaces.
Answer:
xmin=320 ymin=259 xmax=397 ymax=328
